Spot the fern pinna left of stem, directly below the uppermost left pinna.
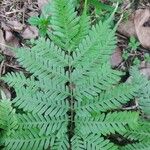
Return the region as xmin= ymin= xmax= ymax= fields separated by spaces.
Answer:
xmin=15 ymin=50 xmax=67 ymax=82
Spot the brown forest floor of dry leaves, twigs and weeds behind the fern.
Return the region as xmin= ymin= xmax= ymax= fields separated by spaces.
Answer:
xmin=0 ymin=0 xmax=150 ymax=103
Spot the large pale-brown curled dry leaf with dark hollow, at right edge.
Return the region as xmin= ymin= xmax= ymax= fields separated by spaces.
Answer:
xmin=134 ymin=9 xmax=150 ymax=48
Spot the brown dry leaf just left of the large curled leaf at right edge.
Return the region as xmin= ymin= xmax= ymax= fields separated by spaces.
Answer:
xmin=118 ymin=16 xmax=136 ymax=37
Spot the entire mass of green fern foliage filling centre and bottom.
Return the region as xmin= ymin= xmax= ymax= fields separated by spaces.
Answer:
xmin=0 ymin=0 xmax=150 ymax=150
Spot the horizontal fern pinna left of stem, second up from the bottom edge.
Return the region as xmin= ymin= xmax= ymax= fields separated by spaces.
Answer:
xmin=17 ymin=113 xmax=68 ymax=137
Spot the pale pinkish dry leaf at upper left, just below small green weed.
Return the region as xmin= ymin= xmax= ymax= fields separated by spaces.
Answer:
xmin=21 ymin=26 xmax=38 ymax=39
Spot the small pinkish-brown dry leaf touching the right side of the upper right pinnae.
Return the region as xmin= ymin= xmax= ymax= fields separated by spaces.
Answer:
xmin=110 ymin=47 xmax=122 ymax=67
